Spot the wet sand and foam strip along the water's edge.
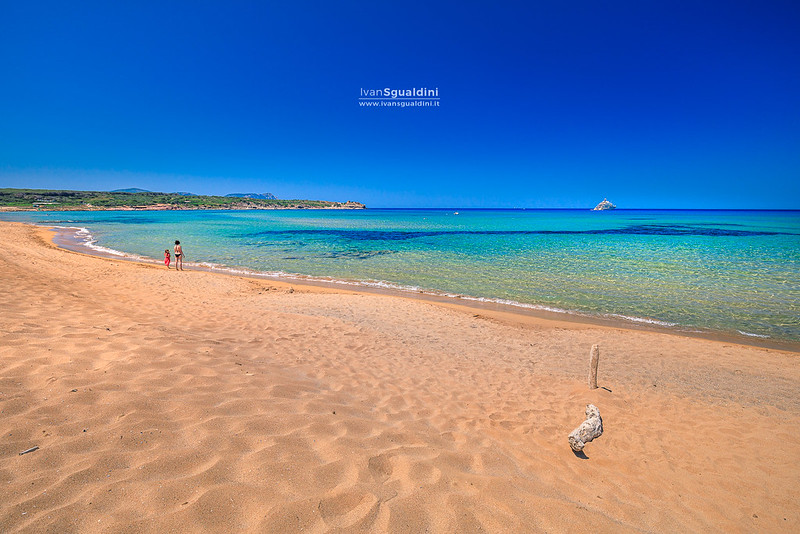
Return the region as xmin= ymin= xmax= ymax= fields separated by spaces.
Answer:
xmin=43 ymin=223 xmax=800 ymax=353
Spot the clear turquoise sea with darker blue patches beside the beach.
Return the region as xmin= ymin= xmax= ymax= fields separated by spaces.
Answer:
xmin=0 ymin=209 xmax=800 ymax=341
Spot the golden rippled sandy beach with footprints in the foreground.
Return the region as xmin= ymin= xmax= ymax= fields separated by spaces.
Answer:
xmin=0 ymin=223 xmax=800 ymax=533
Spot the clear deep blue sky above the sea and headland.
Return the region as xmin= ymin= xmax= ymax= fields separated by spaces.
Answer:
xmin=0 ymin=0 xmax=800 ymax=208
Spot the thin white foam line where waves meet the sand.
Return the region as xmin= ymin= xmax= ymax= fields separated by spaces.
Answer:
xmin=48 ymin=225 xmax=770 ymax=339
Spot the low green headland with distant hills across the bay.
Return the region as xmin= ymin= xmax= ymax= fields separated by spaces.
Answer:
xmin=0 ymin=189 xmax=365 ymax=210
